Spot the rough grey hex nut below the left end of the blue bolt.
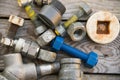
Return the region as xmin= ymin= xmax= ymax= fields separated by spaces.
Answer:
xmin=38 ymin=49 xmax=56 ymax=62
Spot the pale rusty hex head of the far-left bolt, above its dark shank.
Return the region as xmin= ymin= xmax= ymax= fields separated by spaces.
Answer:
xmin=8 ymin=15 xmax=24 ymax=26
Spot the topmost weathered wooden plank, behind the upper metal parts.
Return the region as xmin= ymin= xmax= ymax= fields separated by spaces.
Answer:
xmin=0 ymin=0 xmax=120 ymax=20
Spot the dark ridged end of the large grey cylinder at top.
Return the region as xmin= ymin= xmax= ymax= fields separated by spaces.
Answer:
xmin=51 ymin=0 xmax=66 ymax=15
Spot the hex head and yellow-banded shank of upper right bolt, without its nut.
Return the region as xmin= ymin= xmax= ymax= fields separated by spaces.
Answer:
xmin=64 ymin=2 xmax=92 ymax=28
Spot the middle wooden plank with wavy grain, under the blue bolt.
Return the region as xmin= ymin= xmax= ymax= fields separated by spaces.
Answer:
xmin=0 ymin=19 xmax=120 ymax=74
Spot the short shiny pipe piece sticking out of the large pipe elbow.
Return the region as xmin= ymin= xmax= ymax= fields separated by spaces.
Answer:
xmin=37 ymin=62 xmax=60 ymax=76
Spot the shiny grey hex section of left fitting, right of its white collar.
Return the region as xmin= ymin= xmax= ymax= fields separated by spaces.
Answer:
xmin=27 ymin=42 xmax=40 ymax=58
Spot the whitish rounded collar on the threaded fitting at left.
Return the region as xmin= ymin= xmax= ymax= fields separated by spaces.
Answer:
xmin=15 ymin=38 xmax=25 ymax=52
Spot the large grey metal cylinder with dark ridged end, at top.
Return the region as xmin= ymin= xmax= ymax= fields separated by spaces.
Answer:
xmin=39 ymin=0 xmax=66 ymax=29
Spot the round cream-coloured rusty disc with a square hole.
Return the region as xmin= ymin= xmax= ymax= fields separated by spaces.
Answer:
xmin=86 ymin=11 xmax=120 ymax=44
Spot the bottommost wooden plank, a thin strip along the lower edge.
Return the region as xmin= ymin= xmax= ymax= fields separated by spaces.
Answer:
xmin=39 ymin=74 xmax=120 ymax=80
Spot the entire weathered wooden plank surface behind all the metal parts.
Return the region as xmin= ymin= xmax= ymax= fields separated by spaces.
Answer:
xmin=0 ymin=0 xmax=120 ymax=80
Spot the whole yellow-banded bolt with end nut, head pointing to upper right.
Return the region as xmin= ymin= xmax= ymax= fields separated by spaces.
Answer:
xmin=55 ymin=2 xmax=92 ymax=36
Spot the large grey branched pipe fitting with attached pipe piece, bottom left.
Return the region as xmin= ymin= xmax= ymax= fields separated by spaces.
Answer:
xmin=2 ymin=53 xmax=60 ymax=80
